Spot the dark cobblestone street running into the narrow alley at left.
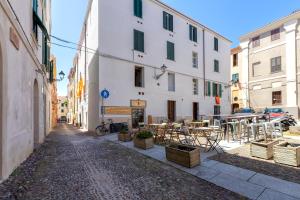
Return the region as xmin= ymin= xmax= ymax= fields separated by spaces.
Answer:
xmin=0 ymin=125 xmax=245 ymax=200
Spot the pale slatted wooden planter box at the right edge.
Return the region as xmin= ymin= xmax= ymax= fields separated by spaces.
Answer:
xmin=274 ymin=142 xmax=300 ymax=167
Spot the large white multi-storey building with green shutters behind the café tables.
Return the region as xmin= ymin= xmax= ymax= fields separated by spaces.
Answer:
xmin=77 ymin=0 xmax=231 ymax=130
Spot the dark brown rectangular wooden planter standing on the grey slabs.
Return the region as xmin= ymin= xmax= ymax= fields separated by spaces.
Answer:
xmin=166 ymin=144 xmax=200 ymax=168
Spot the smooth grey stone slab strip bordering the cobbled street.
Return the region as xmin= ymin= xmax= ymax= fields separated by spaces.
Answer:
xmin=106 ymin=135 xmax=300 ymax=200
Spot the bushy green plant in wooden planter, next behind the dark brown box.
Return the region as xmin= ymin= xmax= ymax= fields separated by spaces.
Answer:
xmin=133 ymin=131 xmax=154 ymax=150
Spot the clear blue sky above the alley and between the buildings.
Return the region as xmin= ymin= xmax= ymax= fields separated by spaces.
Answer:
xmin=52 ymin=0 xmax=300 ymax=95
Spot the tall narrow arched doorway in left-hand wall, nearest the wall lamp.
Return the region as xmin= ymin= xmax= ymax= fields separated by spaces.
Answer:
xmin=33 ymin=79 xmax=39 ymax=147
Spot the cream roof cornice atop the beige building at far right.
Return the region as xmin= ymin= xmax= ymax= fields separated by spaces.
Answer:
xmin=240 ymin=11 xmax=300 ymax=41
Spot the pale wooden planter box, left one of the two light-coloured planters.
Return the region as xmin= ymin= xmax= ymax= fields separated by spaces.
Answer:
xmin=250 ymin=139 xmax=279 ymax=160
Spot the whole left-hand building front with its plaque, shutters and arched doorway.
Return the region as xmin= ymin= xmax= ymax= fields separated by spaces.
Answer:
xmin=0 ymin=0 xmax=51 ymax=180
